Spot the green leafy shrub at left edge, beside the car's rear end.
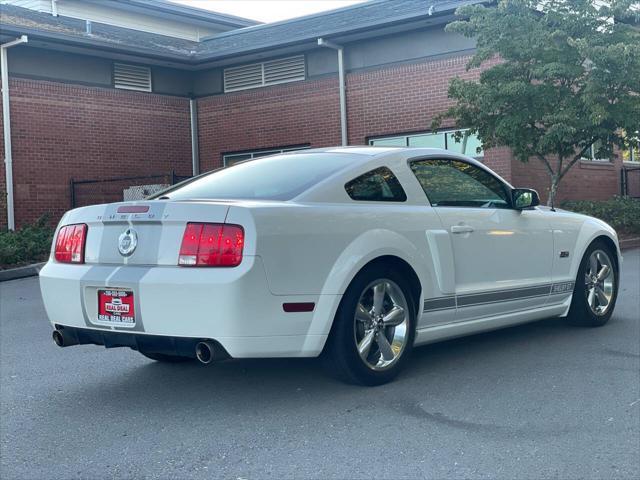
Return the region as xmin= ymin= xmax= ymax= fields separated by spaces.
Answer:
xmin=0 ymin=215 xmax=54 ymax=268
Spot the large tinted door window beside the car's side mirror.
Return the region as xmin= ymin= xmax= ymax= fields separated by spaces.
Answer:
xmin=411 ymin=160 xmax=510 ymax=208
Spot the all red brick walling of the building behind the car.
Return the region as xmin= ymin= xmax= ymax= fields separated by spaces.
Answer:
xmin=0 ymin=53 xmax=620 ymax=231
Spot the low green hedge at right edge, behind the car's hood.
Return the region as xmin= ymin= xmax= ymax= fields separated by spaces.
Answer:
xmin=562 ymin=197 xmax=640 ymax=233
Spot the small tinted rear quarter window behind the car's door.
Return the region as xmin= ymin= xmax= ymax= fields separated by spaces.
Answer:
xmin=344 ymin=167 xmax=407 ymax=202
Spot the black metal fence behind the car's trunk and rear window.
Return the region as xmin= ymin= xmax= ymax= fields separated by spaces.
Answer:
xmin=70 ymin=172 xmax=189 ymax=208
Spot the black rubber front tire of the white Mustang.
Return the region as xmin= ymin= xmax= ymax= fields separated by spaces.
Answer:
xmin=567 ymin=240 xmax=619 ymax=327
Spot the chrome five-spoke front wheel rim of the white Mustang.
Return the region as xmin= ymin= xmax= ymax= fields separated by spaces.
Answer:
xmin=584 ymin=250 xmax=615 ymax=316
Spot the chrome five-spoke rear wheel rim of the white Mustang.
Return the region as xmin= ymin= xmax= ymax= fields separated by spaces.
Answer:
xmin=354 ymin=279 xmax=409 ymax=371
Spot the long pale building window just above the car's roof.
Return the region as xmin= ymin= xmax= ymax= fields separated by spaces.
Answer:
xmin=369 ymin=129 xmax=484 ymax=158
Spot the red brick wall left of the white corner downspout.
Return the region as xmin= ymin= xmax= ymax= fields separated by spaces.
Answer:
xmin=0 ymin=78 xmax=191 ymax=226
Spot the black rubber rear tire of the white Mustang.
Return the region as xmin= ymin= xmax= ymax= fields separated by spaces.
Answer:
xmin=323 ymin=263 xmax=416 ymax=386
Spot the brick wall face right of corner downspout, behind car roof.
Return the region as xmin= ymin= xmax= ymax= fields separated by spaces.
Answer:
xmin=198 ymin=57 xmax=511 ymax=180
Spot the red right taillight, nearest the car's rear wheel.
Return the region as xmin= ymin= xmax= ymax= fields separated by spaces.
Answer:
xmin=178 ymin=223 xmax=244 ymax=267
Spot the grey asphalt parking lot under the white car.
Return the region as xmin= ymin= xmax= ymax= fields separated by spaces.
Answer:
xmin=0 ymin=250 xmax=640 ymax=479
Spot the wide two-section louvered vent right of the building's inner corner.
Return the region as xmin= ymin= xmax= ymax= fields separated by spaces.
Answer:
xmin=224 ymin=55 xmax=306 ymax=92
